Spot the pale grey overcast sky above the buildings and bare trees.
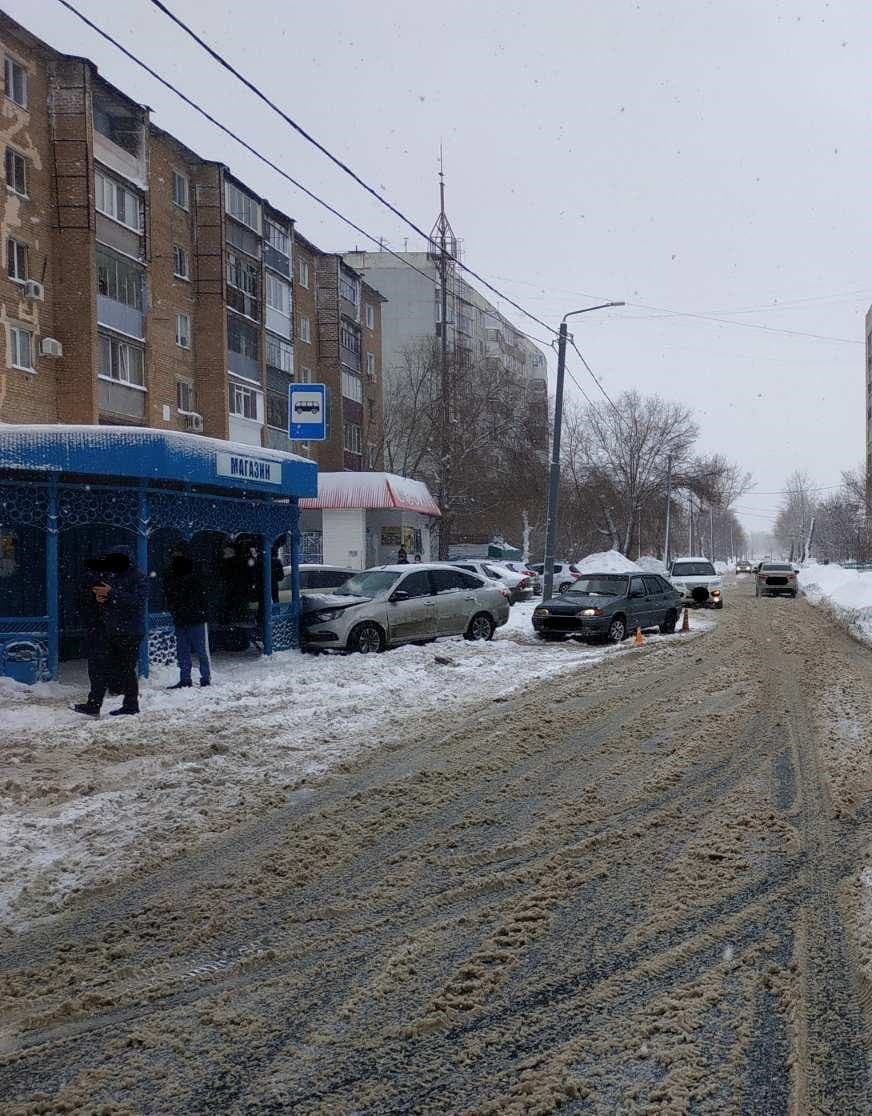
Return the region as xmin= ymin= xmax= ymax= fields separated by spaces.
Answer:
xmin=15 ymin=0 xmax=872 ymax=529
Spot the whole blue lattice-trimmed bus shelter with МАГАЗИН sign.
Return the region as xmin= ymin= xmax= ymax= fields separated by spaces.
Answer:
xmin=0 ymin=425 xmax=317 ymax=682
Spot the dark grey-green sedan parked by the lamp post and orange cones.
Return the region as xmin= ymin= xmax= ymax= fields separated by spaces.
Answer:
xmin=533 ymin=574 xmax=681 ymax=643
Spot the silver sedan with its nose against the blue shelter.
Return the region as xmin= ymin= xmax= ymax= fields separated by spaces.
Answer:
xmin=300 ymin=564 xmax=509 ymax=653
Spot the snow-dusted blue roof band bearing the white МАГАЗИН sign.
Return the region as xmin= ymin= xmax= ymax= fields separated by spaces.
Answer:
xmin=0 ymin=424 xmax=317 ymax=498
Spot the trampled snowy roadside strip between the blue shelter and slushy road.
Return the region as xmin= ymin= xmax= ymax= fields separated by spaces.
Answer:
xmin=0 ymin=602 xmax=711 ymax=932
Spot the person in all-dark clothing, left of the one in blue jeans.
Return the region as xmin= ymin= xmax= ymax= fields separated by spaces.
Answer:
xmin=74 ymin=546 xmax=148 ymax=716
